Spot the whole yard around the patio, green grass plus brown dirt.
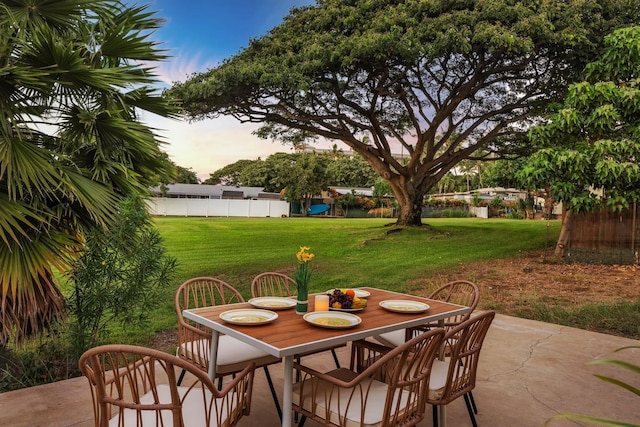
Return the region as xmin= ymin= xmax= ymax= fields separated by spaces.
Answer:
xmin=7 ymin=217 xmax=640 ymax=391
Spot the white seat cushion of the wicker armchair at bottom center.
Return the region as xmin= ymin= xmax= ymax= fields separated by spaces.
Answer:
xmin=293 ymin=368 xmax=417 ymax=427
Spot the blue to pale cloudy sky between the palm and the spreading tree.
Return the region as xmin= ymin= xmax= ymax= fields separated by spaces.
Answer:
xmin=144 ymin=0 xmax=315 ymax=179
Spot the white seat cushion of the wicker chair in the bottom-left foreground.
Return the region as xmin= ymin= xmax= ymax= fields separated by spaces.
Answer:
xmin=109 ymin=384 xmax=237 ymax=427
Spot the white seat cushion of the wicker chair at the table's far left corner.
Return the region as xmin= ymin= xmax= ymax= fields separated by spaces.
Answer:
xmin=178 ymin=335 xmax=280 ymax=375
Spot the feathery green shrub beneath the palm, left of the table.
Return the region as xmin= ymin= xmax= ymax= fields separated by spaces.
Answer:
xmin=68 ymin=196 xmax=175 ymax=355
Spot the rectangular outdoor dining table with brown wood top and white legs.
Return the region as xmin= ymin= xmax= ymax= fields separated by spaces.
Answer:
xmin=183 ymin=287 xmax=470 ymax=427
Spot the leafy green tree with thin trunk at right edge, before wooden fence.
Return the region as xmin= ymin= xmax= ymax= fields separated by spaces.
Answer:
xmin=520 ymin=26 xmax=640 ymax=256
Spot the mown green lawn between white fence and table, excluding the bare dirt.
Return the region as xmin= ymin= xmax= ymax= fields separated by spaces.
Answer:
xmin=132 ymin=217 xmax=560 ymax=342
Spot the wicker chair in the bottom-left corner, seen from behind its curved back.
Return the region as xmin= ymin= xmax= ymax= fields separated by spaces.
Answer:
xmin=79 ymin=345 xmax=255 ymax=427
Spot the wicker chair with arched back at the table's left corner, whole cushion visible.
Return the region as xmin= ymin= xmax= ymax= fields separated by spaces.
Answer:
xmin=175 ymin=277 xmax=282 ymax=418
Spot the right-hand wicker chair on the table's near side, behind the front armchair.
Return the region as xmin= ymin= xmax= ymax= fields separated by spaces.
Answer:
xmin=427 ymin=311 xmax=496 ymax=427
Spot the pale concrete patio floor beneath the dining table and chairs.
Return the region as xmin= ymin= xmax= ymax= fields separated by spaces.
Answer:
xmin=0 ymin=315 xmax=640 ymax=427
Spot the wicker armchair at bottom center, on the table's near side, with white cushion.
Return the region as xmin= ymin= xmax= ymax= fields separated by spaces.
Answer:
xmin=293 ymin=329 xmax=444 ymax=427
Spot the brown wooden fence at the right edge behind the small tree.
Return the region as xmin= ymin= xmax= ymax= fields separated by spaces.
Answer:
xmin=567 ymin=204 xmax=640 ymax=264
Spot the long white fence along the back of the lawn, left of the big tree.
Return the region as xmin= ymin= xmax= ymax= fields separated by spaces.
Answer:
xmin=147 ymin=197 xmax=289 ymax=217
